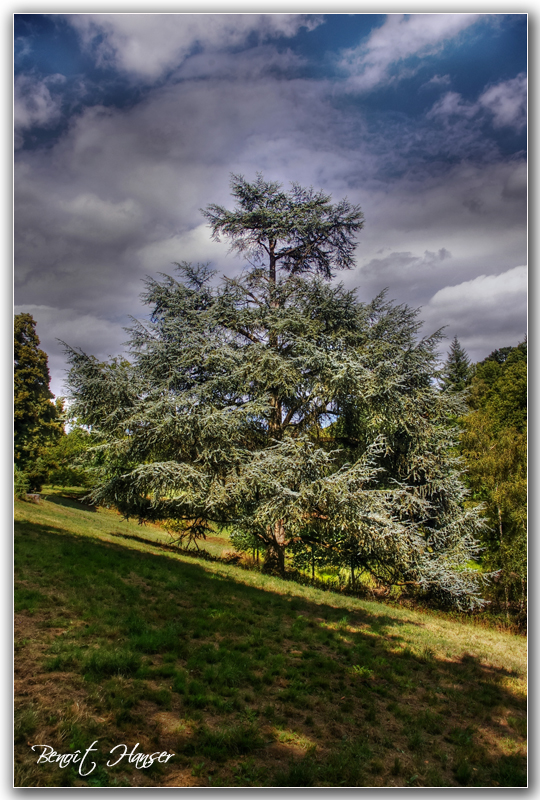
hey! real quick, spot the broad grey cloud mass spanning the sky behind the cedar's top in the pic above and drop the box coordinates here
[15,15,526,391]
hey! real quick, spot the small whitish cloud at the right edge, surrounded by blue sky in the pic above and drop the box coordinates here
[426,73,527,133]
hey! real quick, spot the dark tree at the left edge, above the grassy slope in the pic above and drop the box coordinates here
[13,314,63,491]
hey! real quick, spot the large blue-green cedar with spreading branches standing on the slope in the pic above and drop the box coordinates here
[63,176,486,606]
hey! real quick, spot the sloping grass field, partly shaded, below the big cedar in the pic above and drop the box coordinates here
[15,492,526,786]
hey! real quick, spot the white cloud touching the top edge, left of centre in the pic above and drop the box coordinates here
[66,14,322,82]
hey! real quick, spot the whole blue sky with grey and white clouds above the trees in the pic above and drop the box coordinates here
[14,13,527,395]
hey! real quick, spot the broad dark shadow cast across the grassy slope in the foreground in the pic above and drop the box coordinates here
[15,520,526,786]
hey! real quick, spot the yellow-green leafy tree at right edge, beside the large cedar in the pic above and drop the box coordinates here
[461,342,527,616]
